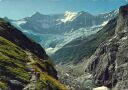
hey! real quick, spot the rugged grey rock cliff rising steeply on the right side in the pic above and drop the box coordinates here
[86,5,128,90]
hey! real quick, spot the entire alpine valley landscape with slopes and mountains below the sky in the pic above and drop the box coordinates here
[0,1,128,90]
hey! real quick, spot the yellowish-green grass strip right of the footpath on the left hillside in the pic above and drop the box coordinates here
[28,53,68,90]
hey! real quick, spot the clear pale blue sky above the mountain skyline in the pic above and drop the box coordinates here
[0,0,128,19]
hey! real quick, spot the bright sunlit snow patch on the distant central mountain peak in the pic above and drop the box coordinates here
[61,11,78,23]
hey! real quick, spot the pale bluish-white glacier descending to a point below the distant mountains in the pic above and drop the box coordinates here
[11,20,108,55]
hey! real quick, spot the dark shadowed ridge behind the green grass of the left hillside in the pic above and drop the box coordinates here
[0,17,48,59]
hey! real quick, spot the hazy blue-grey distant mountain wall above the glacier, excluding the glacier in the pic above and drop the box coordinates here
[17,11,118,34]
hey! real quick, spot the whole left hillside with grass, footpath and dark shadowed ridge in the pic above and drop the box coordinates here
[0,19,67,90]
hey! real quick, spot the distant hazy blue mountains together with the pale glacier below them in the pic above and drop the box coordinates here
[12,10,118,58]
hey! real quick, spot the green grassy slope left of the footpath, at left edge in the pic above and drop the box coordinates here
[0,37,30,87]
